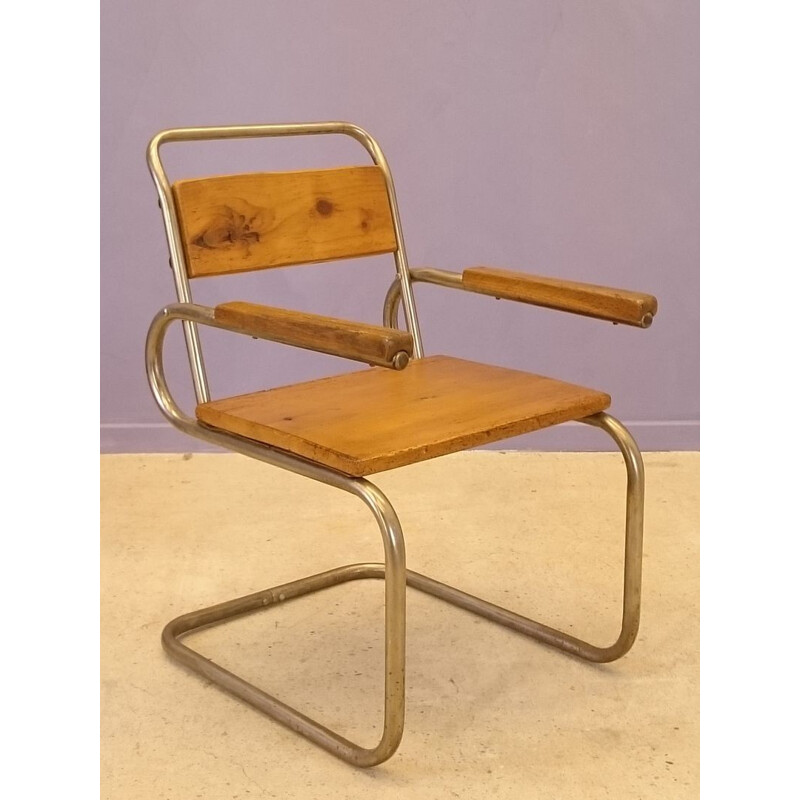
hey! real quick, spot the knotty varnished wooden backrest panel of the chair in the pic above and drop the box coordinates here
[172,166,397,278]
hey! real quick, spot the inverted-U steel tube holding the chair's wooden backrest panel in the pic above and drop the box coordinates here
[147,122,423,403]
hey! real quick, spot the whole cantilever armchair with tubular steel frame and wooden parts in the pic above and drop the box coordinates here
[146,122,657,767]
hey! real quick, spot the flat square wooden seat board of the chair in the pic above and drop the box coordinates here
[197,356,611,476]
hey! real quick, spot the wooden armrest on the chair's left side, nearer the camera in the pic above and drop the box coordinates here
[214,301,414,369]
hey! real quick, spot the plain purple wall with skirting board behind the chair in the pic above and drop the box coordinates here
[101,0,699,452]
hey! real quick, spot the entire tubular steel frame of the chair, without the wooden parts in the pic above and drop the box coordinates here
[145,122,644,767]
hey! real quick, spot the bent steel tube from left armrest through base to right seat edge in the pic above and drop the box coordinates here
[145,304,644,767]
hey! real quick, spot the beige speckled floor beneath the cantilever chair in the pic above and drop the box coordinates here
[102,452,699,800]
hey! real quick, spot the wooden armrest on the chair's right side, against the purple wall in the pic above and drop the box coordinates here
[462,267,658,328]
